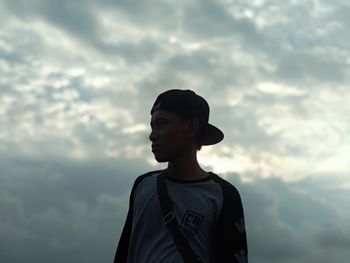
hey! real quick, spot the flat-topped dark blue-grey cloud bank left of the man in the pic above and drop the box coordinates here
[0,155,147,263]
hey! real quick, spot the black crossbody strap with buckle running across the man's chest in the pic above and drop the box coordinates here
[157,170,201,263]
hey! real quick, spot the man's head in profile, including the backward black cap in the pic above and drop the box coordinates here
[149,89,224,161]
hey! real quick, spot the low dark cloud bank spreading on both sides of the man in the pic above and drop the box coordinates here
[0,154,350,262]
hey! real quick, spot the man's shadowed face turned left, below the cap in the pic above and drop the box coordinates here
[149,110,191,162]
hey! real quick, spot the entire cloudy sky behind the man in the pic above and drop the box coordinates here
[0,0,350,263]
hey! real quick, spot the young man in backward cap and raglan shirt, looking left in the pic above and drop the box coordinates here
[114,89,248,263]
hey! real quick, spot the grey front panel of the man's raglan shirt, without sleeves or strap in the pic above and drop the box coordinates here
[128,172,223,263]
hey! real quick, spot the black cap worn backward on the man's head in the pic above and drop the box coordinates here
[151,89,224,145]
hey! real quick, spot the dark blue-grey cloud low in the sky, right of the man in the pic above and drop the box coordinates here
[228,175,350,262]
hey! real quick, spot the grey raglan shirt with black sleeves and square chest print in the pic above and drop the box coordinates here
[114,170,248,263]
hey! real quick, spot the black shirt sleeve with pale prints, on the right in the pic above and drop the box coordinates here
[214,181,248,263]
